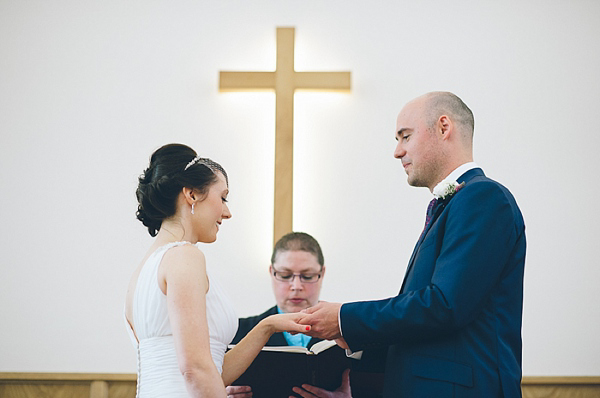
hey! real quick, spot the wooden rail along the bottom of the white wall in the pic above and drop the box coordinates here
[0,373,600,398]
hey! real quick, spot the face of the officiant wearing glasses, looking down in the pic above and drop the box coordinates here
[269,250,325,312]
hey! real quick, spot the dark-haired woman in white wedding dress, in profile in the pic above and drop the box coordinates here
[125,144,309,398]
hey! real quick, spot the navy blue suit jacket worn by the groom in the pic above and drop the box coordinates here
[340,168,525,398]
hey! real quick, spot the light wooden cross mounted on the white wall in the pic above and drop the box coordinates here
[219,28,350,243]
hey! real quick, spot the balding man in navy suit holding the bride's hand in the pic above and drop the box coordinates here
[301,92,525,398]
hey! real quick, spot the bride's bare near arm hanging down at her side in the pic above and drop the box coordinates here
[158,245,226,397]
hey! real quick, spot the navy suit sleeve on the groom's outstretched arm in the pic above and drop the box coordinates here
[340,180,520,351]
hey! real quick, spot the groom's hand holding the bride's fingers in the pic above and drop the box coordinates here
[298,301,342,340]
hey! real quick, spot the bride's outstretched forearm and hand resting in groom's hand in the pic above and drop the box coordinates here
[222,313,310,386]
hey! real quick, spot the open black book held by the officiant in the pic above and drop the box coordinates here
[229,340,352,398]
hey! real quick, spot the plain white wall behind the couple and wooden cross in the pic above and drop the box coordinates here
[0,0,600,375]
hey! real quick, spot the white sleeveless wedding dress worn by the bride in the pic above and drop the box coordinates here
[126,242,238,398]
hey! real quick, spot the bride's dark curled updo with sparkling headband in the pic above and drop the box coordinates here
[135,144,227,236]
